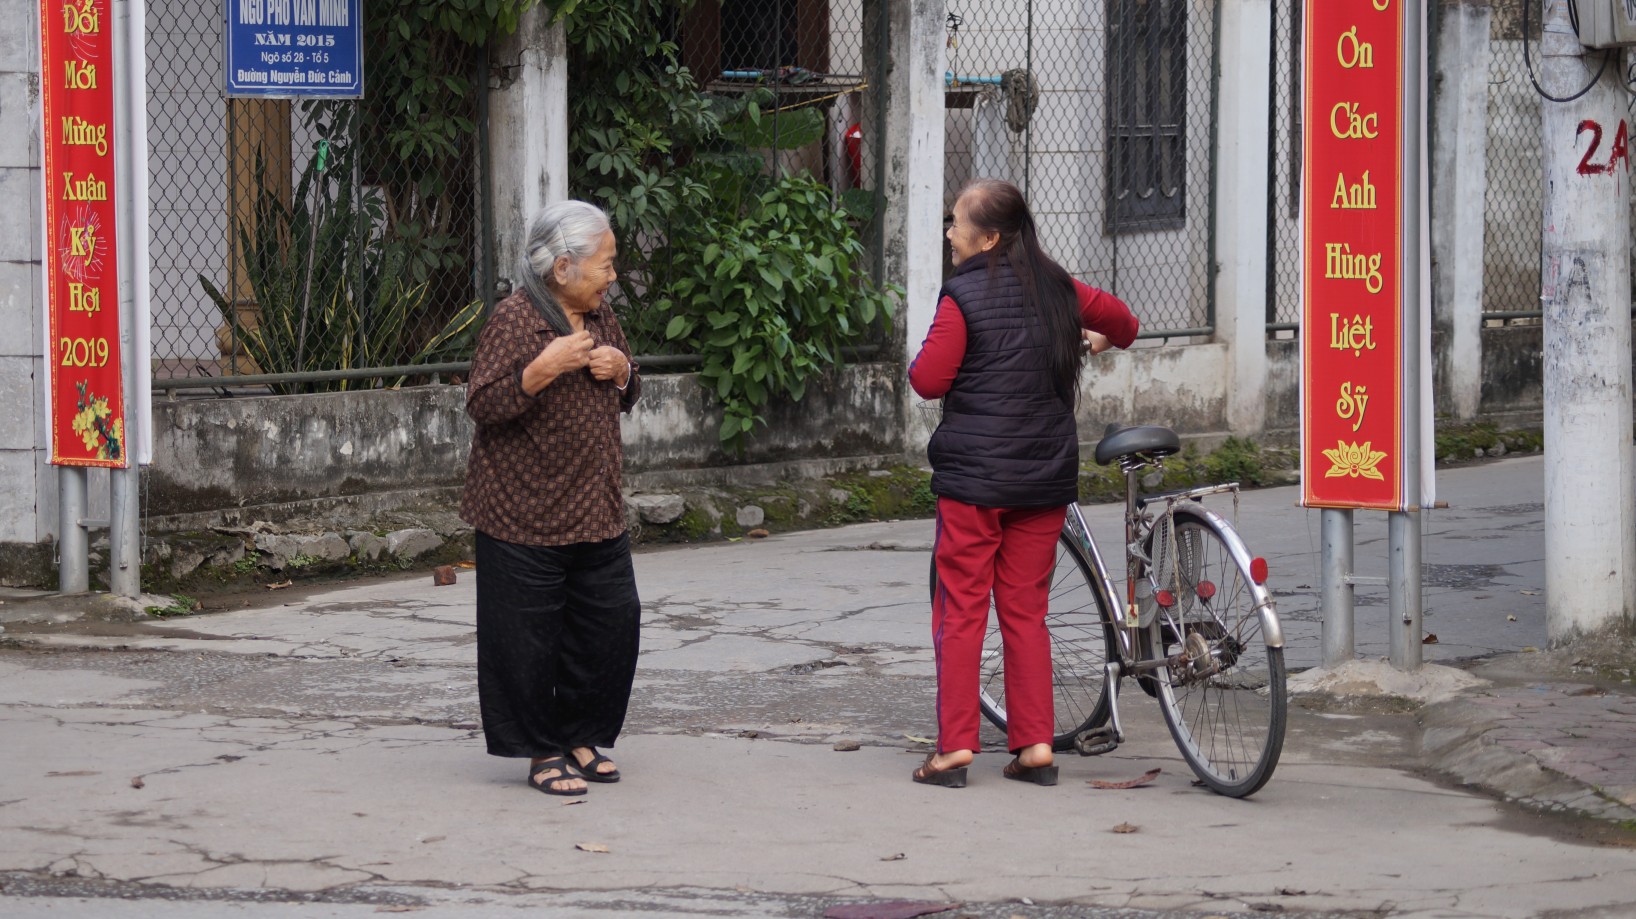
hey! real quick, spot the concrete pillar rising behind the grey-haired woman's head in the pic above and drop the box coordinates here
[488,5,568,286]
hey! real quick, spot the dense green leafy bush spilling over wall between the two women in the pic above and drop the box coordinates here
[566,0,900,450]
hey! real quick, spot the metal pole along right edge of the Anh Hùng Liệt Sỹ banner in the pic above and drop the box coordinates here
[1387,3,1425,670]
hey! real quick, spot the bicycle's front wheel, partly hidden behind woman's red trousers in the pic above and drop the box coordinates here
[931,531,1116,751]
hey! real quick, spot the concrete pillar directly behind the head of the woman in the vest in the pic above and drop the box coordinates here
[864,0,946,455]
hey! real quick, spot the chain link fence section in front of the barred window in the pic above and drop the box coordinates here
[944,0,1217,337]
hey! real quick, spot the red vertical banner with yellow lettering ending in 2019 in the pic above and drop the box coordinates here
[39,0,128,466]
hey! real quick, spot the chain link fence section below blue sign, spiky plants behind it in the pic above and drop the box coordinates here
[147,0,483,392]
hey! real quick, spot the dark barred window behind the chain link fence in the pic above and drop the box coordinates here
[1104,0,1188,232]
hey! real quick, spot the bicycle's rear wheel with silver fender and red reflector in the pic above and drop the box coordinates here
[1148,504,1288,798]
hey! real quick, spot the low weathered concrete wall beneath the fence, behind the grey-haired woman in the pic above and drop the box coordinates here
[147,365,903,517]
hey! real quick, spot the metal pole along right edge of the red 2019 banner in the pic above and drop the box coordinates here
[108,0,149,597]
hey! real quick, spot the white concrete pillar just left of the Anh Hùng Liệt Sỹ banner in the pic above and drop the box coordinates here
[1216,0,1273,433]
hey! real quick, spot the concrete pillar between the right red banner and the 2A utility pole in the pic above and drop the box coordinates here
[1430,0,1494,420]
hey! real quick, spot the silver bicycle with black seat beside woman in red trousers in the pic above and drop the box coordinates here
[931,425,1288,798]
